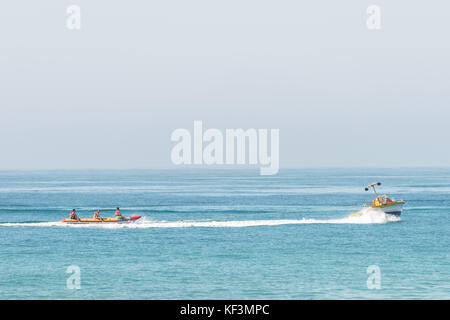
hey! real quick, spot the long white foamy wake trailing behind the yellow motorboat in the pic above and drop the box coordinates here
[0,208,401,229]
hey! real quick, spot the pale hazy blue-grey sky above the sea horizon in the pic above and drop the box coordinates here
[0,0,450,168]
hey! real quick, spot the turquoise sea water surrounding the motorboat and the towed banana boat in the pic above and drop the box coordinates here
[0,169,450,299]
